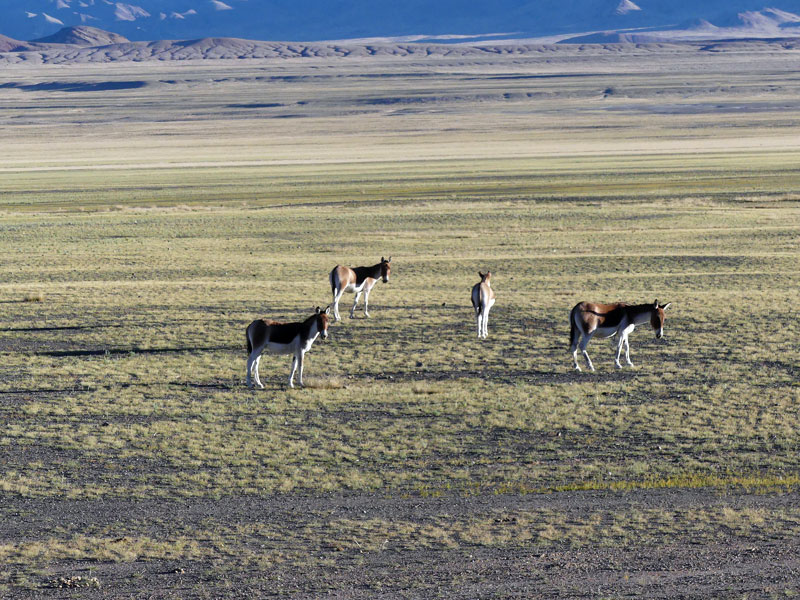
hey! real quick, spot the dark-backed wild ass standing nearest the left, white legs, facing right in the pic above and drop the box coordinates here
[247,306,331,388]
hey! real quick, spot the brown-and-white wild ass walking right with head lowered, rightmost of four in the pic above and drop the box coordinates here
[569,300,672,371]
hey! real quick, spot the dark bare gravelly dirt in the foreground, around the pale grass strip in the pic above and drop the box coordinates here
[6,490,800,599]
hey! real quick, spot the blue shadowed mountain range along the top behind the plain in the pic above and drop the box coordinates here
[0,0,800,44]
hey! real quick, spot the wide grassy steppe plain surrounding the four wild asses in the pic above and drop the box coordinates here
[0,43,800,598]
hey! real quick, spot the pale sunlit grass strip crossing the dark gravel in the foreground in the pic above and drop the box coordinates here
[6,500,800,567]
